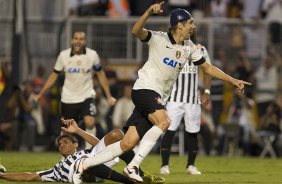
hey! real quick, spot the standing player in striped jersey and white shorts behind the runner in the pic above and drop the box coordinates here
[160,31,211,175]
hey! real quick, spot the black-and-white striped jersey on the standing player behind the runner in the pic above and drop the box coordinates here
[168,44,211,104]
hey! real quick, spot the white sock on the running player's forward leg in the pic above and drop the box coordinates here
[128,126,163,168]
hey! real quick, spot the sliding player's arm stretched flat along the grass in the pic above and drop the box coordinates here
[0,172,41,182]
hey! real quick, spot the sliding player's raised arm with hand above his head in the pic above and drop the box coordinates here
[61,118,100,146]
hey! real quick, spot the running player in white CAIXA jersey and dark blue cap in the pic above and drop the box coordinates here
[73,2,250,184]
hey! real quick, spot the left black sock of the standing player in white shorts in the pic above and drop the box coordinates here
[161,130,175,166]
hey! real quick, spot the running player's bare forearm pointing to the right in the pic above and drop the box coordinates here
[200,62,252,92]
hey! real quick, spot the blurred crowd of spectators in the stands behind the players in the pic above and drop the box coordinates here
[0,0,282,156]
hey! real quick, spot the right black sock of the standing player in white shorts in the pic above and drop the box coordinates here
[185,132,198,168]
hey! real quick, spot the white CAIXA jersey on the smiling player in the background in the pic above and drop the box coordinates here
[54,48,100,104]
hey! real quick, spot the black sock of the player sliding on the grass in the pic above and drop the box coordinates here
[82,164,134,184]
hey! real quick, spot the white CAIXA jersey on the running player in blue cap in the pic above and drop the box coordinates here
[133,31,202,102]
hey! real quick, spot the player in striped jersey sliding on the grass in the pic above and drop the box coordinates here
[0,119,164,184]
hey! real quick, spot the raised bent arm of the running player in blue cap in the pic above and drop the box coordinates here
[132,2,164,40]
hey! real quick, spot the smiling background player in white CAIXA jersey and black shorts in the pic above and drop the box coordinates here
[35,31,116,147]
